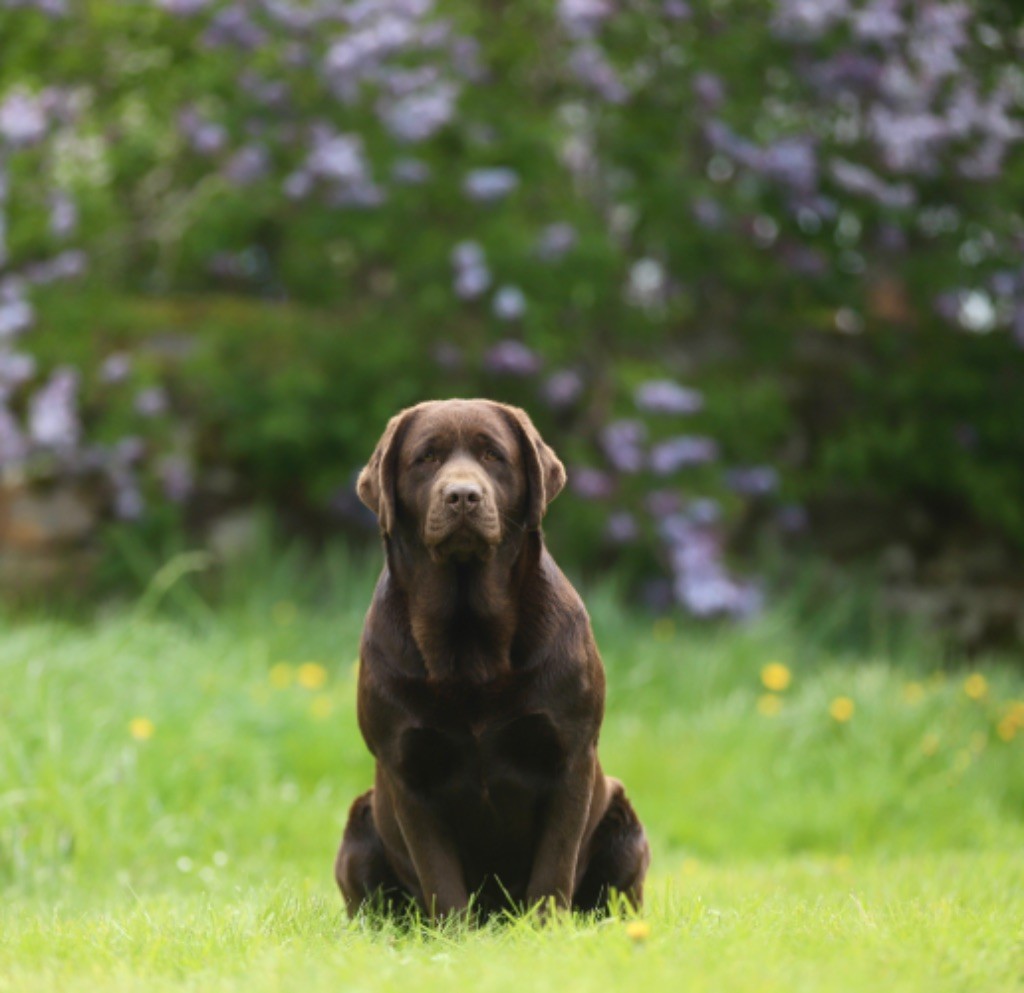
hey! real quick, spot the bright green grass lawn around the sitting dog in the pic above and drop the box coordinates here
[0,555,1024,993]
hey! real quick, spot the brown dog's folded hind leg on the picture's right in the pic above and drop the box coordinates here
[572,777,650,911]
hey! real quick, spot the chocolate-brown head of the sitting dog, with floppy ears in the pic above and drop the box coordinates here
[356,400,565,561]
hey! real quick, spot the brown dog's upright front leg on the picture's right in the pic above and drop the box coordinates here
[526,747,597,910]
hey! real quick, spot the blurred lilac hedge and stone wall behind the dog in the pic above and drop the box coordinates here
[0,0,1024,652]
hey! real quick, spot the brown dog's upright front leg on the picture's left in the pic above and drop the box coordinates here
[387,777,469,919]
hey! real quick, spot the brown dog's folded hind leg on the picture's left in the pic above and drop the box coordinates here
[334,789,413,916]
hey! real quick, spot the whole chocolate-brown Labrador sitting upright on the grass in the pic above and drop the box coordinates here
[335,400,650,916]
